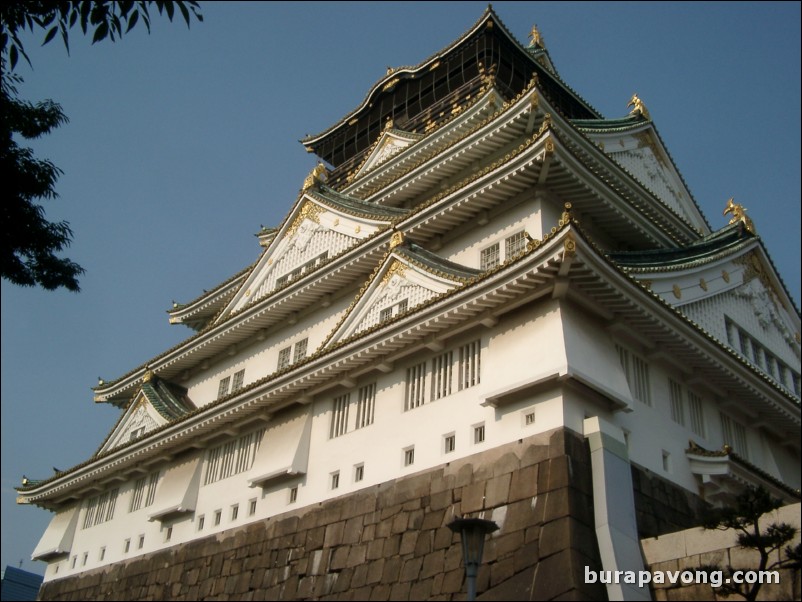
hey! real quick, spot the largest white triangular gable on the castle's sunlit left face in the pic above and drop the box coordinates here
[218,189,403,320]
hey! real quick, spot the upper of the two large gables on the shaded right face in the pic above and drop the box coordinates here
[575,119,709,232]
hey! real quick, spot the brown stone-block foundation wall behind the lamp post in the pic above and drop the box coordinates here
[40,429,606,600]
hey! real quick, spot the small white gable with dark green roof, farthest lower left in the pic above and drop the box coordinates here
[98,372,193,453]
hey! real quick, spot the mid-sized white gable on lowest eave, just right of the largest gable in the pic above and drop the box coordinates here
[327,234,478,344]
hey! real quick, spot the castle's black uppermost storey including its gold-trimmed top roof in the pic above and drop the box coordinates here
[301,8,601,168]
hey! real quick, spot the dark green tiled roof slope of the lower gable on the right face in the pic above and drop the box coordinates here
[608,222,755,270]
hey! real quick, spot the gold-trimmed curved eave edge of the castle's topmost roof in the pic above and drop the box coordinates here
[301,7,601,152]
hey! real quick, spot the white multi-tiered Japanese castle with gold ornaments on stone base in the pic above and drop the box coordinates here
[17,8,802,600]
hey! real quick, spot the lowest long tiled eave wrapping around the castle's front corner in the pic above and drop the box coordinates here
[18,220,802,508]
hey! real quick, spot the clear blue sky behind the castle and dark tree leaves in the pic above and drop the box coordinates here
[0,2,800,572]
